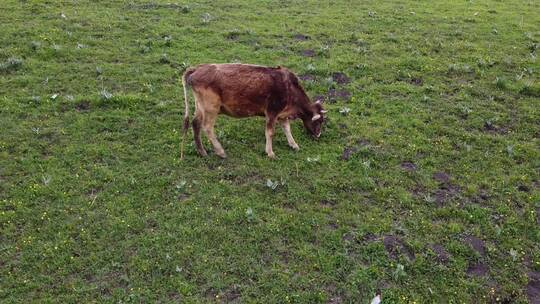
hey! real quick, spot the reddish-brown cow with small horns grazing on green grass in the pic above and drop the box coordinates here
[181,64,325,158]
